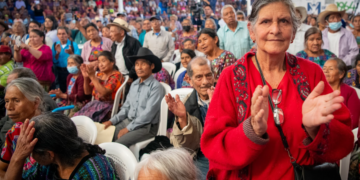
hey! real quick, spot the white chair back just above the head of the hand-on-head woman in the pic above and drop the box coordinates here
[71,116,97,144]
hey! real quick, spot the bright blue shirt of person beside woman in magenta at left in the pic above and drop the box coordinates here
[51,40,81,68]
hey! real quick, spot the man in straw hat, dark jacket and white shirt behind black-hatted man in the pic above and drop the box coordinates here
[107,18,141,80]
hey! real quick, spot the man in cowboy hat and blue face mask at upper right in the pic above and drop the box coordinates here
[318,4,359,66]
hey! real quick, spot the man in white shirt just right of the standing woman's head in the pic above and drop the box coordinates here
[287,6,311,55]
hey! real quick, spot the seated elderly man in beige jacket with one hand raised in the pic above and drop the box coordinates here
[165,57,215,175]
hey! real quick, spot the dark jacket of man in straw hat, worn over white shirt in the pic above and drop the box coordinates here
[111,33,141,80]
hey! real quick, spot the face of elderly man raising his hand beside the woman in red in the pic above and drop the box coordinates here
[190,63,215,97]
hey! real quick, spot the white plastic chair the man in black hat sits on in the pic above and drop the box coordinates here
[130,82,171,161]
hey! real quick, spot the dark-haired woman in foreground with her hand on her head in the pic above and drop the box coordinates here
[5,113,119,180]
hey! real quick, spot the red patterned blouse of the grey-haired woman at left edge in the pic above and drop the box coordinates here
[1,122,36,178]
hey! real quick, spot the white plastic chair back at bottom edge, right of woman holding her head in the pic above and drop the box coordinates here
[99,142,137,180]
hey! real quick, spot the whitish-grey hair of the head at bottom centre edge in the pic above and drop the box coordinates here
[135,148,200,180]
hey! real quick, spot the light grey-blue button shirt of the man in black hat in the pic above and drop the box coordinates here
[110,75,165,131]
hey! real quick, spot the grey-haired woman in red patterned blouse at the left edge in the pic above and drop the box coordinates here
[0,78,45,179]
